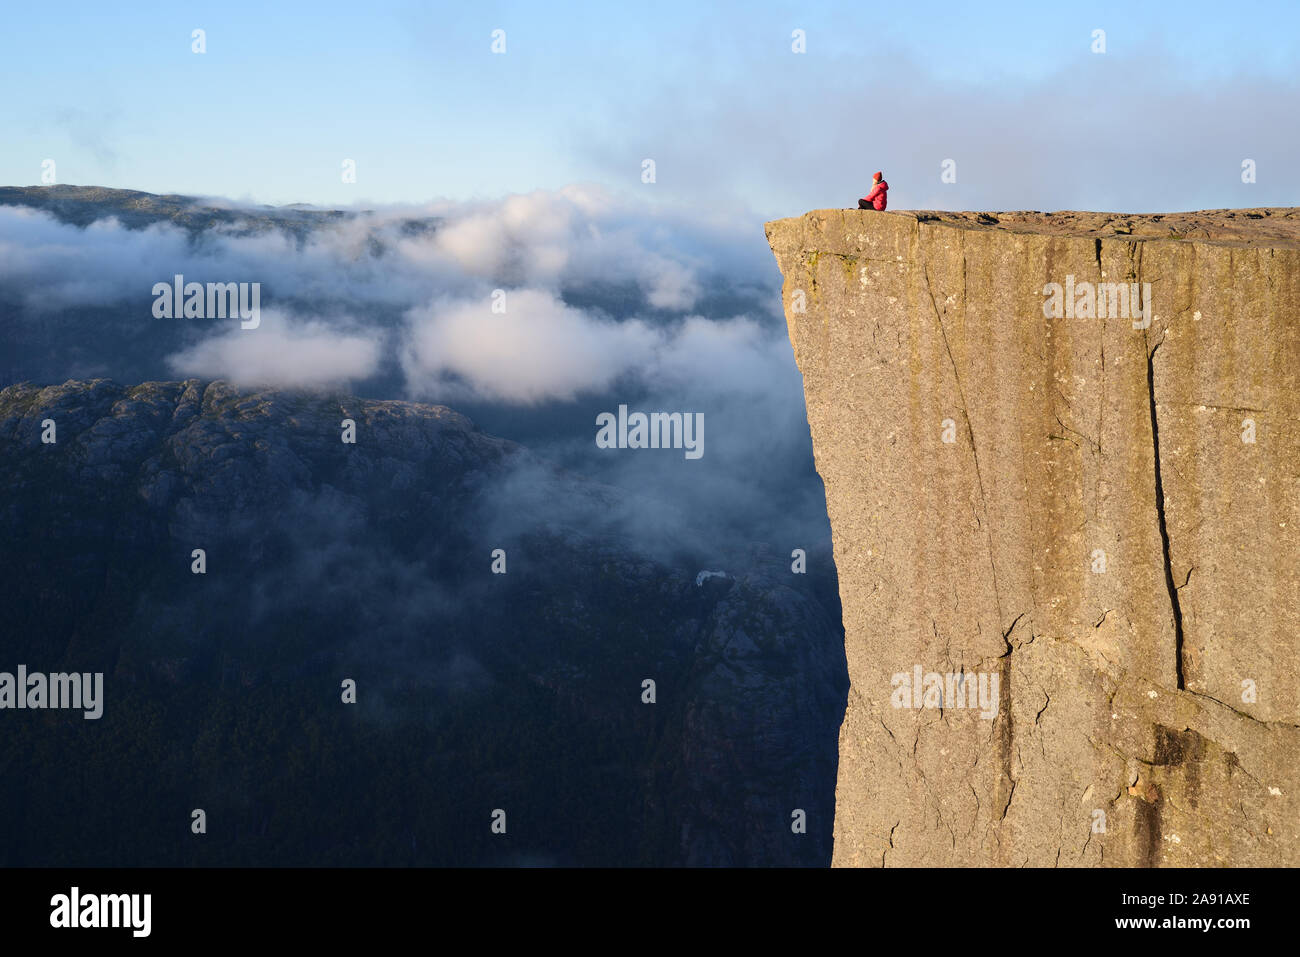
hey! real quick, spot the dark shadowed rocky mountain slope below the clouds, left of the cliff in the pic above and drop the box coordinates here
[0,380,845,865]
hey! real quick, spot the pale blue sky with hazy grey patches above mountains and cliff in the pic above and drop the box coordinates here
[0,0,1300,216]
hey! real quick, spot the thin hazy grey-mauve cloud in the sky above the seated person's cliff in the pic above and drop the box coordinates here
[576,43,1300,218]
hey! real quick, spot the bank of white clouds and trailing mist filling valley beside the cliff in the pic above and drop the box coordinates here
[0,186,827,567]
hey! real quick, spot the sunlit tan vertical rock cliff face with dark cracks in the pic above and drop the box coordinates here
[767,209,1300,866]
